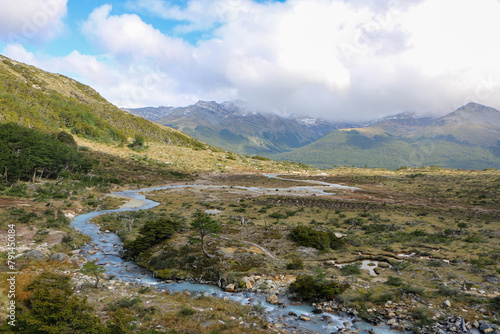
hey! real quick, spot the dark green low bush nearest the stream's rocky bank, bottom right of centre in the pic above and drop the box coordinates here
[289,275,348,301]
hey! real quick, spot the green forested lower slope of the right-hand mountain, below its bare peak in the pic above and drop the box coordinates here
[272,130,500,169]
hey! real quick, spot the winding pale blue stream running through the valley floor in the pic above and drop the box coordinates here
[71,174,397,334]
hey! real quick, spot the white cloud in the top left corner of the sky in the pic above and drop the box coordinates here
[0,0,67,43]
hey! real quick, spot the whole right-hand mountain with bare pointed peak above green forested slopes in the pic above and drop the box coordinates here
[271,103,500,169]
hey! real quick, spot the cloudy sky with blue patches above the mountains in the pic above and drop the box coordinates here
[0,0,500,120]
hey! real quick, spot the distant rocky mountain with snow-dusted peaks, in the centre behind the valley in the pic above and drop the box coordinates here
[124,101,353,155]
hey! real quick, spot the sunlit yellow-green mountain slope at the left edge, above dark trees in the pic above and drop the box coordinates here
[0,55,204,147]
